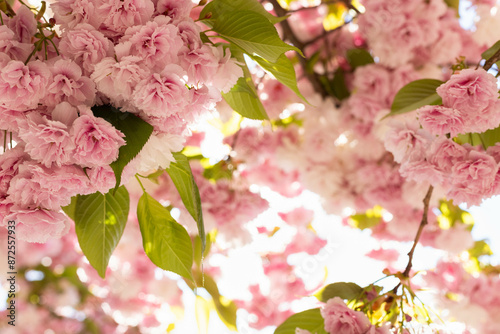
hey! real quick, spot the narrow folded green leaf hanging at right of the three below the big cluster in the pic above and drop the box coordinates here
[166,152,206,251]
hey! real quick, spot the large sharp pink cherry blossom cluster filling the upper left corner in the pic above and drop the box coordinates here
[0,0,243,242]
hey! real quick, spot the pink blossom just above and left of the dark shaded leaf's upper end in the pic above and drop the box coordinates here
[44,59,96,106]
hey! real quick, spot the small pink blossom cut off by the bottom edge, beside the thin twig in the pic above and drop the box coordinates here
[321,297,371,334]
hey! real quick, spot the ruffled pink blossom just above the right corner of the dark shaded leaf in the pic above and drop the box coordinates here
[132,64,189,117]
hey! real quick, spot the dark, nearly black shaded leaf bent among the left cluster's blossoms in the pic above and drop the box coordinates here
[92,104,153,191]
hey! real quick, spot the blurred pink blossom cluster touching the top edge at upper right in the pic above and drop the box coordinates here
[358,0,484,67]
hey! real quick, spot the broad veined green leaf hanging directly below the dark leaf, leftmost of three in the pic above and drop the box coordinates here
[74,186,130,278]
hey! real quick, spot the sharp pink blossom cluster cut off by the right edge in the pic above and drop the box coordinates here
[385,69,500,205]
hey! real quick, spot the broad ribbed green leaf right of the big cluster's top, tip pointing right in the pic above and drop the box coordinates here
[213,10,302,63]
